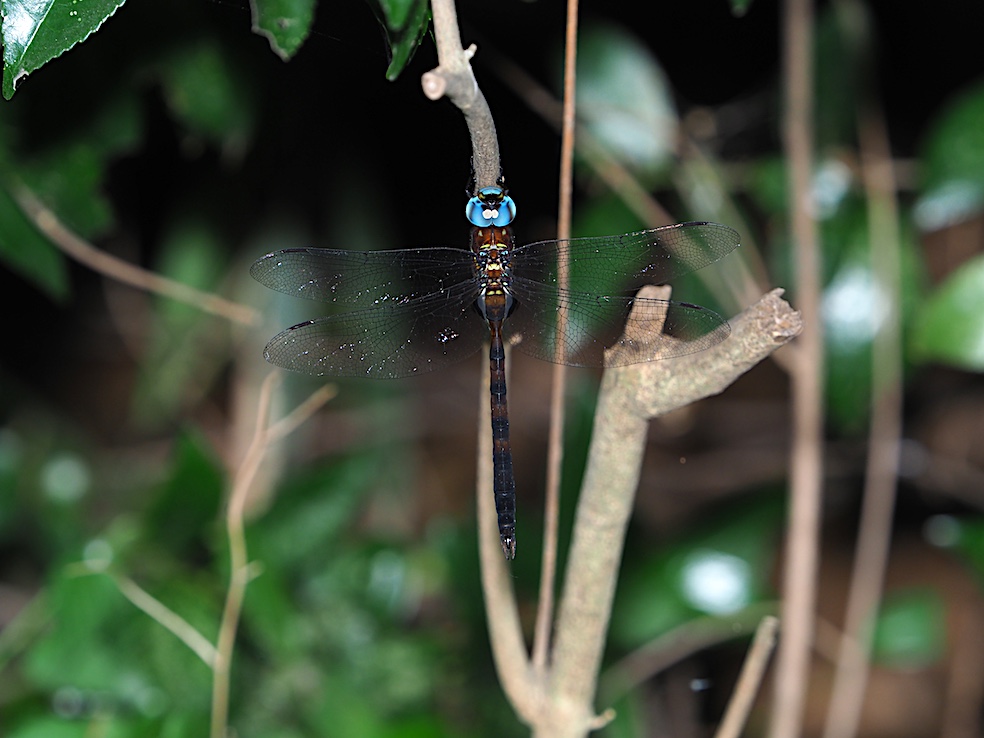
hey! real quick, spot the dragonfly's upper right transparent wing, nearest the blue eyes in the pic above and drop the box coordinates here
[512,218,740,295]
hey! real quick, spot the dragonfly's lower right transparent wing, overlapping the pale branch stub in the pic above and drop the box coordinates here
[504,278,731,366]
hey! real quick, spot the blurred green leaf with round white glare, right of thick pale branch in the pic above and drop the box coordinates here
[611,499,782,648]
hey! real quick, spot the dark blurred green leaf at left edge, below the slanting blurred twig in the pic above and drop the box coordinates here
[0,187,69,300]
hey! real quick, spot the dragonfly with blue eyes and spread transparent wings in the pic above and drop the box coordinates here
[250,186,739,559]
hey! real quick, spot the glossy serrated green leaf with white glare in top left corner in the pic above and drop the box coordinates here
[0,0,125,100]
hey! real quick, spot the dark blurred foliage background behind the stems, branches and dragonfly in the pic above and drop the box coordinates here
[0,0,984,738]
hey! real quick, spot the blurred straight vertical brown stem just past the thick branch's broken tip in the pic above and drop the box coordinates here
[770,0,824,738]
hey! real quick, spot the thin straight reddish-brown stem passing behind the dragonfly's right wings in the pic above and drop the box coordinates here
[533,0,578,670]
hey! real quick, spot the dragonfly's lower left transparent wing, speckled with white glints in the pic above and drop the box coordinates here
[264,284,488,379]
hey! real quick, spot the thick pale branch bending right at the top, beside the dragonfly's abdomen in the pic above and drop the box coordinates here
[549,288,801,732]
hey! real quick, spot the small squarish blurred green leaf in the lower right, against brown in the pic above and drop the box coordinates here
[872,589,946,669]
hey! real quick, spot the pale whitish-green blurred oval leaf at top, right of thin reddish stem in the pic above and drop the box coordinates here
[577,25,677,180]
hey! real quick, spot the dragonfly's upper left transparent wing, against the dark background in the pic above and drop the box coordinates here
[249,248,475,311]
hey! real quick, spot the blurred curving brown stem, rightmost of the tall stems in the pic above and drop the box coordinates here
[824,1,902,738]
